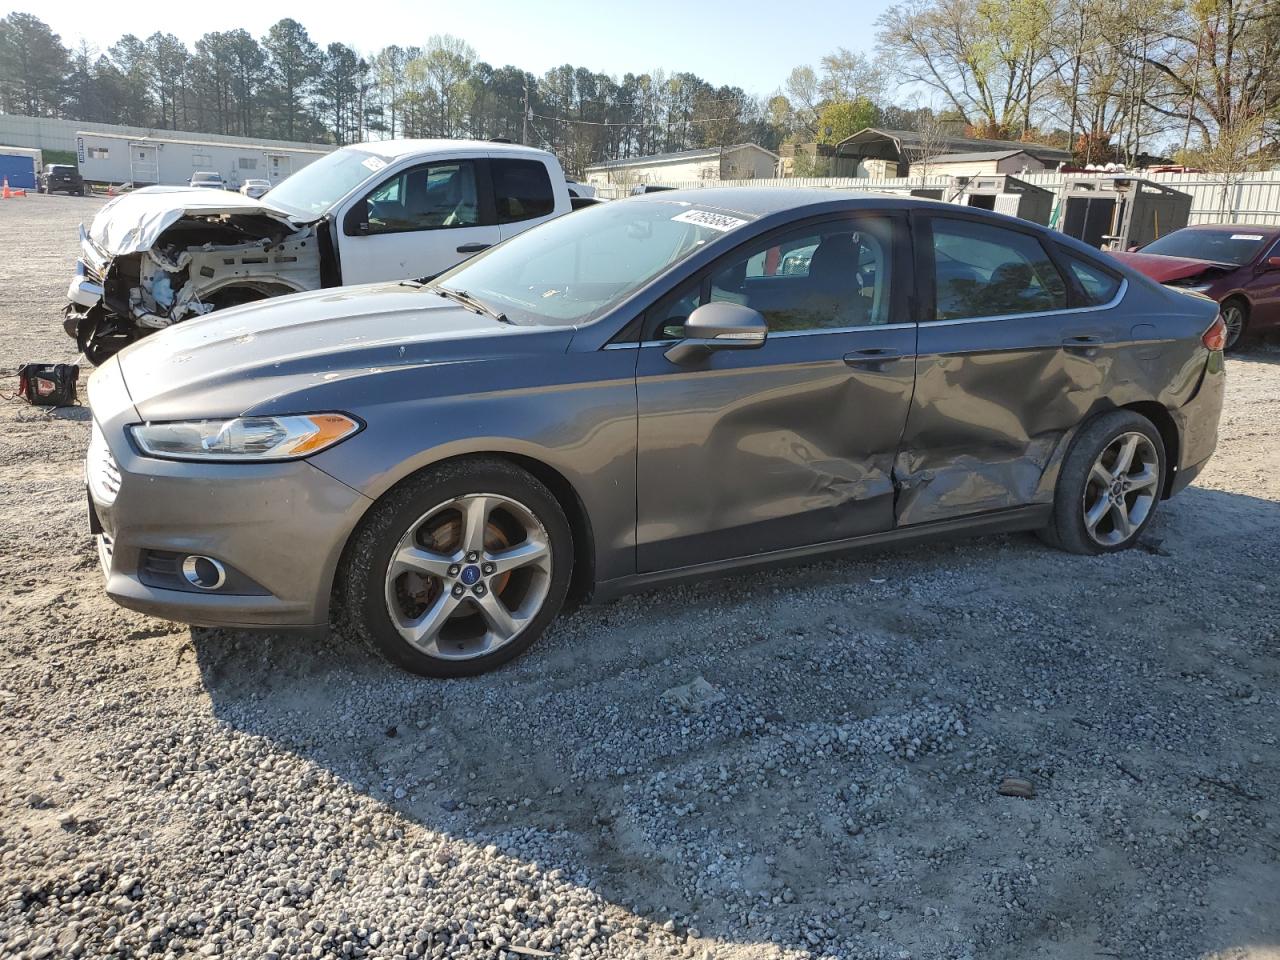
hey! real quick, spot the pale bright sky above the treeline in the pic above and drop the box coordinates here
[0,0,892,95]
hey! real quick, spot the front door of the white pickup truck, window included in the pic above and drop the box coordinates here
[339,157,502,284]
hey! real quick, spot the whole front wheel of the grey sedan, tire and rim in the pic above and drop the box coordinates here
[340,460,573,677]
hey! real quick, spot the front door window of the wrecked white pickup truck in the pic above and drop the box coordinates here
[365,160,480,234]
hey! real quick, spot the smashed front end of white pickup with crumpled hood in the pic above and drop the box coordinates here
[64,188,324,364]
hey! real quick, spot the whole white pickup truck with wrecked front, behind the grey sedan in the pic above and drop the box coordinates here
[64,140,576,364]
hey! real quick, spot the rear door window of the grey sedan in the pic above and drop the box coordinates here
[933,218,1066,320]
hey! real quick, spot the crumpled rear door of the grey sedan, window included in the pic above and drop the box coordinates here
[895,212,1124,526]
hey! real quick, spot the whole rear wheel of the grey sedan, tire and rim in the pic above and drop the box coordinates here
[1043,410,1166,554]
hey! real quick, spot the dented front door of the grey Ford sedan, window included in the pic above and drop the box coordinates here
[636,212,915,572]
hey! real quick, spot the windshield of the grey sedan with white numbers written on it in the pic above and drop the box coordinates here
[432,199,750,324]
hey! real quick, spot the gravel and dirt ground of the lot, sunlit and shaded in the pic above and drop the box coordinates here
[0,197,1280,960]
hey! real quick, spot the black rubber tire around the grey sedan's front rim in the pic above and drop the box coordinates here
[335,458,573,677]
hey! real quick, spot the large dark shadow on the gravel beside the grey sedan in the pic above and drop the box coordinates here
[192,486,1280,959]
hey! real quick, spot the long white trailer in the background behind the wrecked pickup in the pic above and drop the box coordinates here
[76,131,333,189]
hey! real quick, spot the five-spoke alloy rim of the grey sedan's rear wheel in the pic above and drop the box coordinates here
[1084,431,1160,547]
